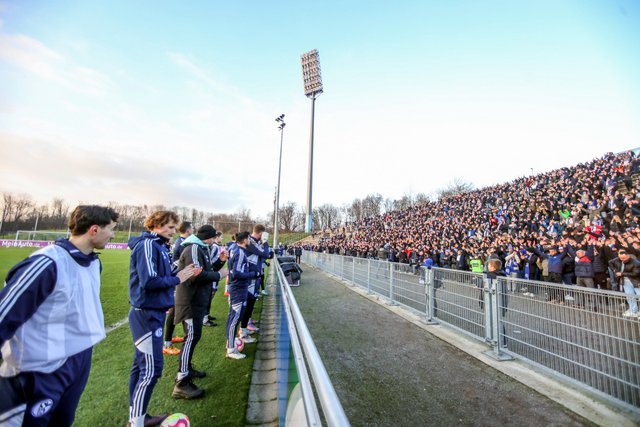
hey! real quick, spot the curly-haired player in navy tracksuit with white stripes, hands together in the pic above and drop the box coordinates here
[129,211,199,427]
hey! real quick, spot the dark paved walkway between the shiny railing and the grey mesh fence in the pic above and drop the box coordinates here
[294,266,631,427]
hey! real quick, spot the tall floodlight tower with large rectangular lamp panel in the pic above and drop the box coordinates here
[300,49,322,233]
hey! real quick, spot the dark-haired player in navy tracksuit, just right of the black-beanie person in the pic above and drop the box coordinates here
[226,231,258,359]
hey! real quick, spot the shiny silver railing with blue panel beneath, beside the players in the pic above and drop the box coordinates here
[272,259,350,427]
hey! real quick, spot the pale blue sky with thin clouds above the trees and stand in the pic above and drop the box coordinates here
[0,0,640,215]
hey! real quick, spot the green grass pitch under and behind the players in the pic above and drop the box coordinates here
[0,248,262,427]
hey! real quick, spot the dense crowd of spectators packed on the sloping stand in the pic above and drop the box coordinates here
[308,151,640,310]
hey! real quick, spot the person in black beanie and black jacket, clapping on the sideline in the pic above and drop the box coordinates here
[172,224,228,399]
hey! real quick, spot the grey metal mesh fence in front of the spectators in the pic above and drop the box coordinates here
[302,251,640,413]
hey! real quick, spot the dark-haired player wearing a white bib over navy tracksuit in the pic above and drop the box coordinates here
[0,205,118,427]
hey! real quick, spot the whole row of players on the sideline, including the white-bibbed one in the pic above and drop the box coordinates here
[0,205,272,427]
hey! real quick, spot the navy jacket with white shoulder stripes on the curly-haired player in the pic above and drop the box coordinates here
[129,231,180,310]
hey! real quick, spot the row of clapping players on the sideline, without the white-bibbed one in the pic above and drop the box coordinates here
[129,211,273,426]
